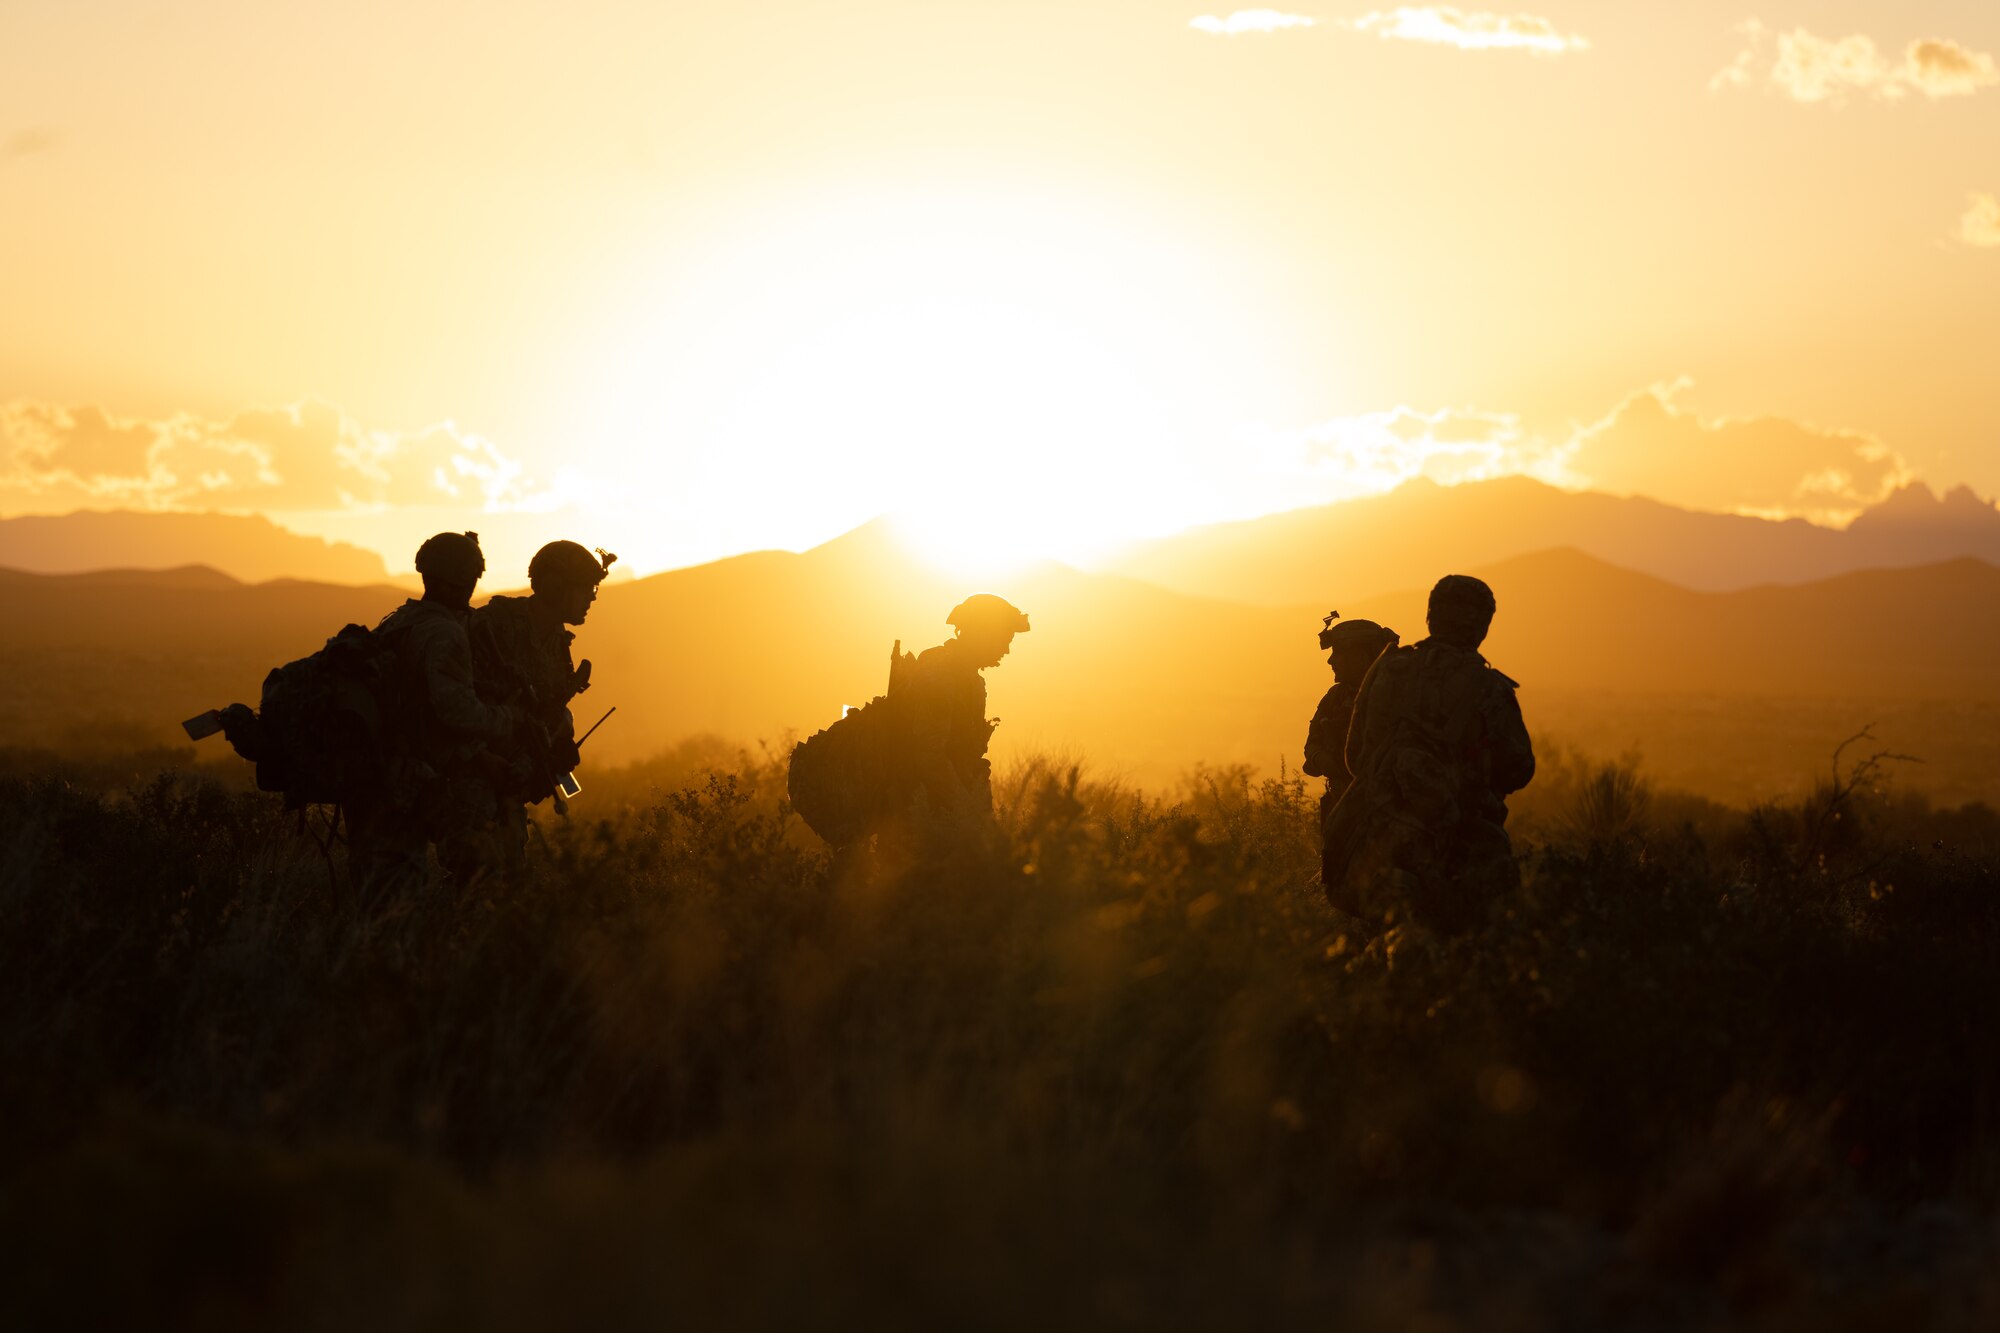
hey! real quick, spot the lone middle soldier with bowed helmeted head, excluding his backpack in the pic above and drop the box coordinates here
[908,592,1028,817]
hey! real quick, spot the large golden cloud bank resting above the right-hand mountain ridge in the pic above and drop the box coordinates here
[1564,384,1912,522]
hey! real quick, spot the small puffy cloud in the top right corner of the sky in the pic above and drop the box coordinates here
[1708,22,2000,104]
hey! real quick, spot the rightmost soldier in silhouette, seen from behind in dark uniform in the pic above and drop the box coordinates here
[1326,574,1534,935]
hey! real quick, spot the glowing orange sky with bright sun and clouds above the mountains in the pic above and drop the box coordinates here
[0,0,2000,568]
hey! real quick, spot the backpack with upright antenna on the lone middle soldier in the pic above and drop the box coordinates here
[786,638,916,847]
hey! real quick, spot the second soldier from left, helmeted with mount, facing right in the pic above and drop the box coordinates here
[460,542,618,881]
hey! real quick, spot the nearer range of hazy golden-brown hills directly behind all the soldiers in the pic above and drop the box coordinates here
[0,524,2000,801]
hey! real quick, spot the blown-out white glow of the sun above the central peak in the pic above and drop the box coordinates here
[578,182,1296,568]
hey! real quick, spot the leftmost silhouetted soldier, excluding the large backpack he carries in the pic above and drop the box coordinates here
[356,532,526,897]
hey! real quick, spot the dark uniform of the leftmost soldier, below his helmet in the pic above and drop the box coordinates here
[344,600,520,893]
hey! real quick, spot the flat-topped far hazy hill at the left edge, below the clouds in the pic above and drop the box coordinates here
[0,510,390,584]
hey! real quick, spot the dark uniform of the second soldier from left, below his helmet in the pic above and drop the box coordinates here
[464,596,590,879]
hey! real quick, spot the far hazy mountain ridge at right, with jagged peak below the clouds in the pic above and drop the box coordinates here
[1110,476,2000,610]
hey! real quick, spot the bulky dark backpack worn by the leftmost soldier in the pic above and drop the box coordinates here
[244,624,404,811]
